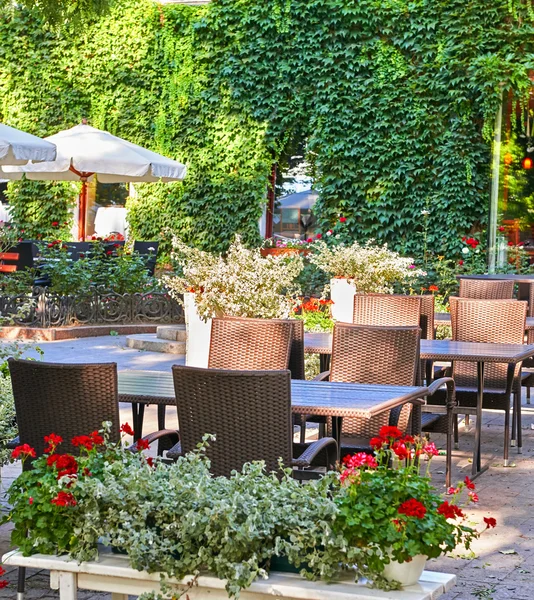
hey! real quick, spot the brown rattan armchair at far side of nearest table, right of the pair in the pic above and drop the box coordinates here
[319,323,454,480]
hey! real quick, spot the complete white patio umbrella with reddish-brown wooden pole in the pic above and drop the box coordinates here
[0,123,187,240]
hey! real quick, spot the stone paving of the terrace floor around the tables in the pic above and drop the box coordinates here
[0,336,534,600]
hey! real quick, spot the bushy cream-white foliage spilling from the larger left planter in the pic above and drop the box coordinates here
[164,236,304,319]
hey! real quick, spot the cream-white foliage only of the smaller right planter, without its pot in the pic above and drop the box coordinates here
[309,240,425,294]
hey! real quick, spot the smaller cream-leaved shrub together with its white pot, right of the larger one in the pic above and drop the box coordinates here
[308,240,424,323]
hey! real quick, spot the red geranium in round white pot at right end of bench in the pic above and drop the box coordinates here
[334,426,496,586]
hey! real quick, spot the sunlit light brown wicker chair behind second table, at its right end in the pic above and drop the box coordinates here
[435,298,527,462]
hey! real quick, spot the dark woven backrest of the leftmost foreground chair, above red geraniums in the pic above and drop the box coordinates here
[8,358,120,455]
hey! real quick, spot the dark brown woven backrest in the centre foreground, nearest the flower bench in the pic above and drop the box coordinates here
[172,365,293,476]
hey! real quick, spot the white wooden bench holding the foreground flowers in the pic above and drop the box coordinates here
[2,548,456,600]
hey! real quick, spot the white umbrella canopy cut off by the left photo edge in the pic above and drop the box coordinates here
[0,123,56,165]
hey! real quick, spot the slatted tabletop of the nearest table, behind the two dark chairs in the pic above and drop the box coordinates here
[118,370,430,419]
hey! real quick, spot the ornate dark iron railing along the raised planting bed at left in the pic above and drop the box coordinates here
[0,287,184,327]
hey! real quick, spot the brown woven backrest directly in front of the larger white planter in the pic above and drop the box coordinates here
[208,318,293,371]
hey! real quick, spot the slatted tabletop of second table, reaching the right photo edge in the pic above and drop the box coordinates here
[304,333,534,363]
